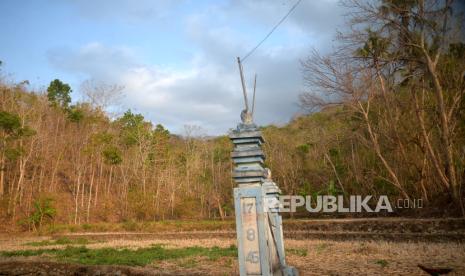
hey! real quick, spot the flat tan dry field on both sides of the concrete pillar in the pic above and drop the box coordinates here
[0,236,465,275]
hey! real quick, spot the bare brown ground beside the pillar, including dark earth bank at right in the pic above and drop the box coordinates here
[0,219,465,275]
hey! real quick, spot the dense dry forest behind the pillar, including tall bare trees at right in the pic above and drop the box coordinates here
[0,0,465,229]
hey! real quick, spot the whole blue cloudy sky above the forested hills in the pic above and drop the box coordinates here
[0,0,344,135]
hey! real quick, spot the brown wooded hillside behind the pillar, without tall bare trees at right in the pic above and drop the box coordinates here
[0,75,463,229]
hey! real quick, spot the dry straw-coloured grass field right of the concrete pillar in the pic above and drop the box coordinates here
[286,240,465,275]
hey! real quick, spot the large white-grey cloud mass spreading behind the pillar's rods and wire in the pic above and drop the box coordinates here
[49,0,344,134]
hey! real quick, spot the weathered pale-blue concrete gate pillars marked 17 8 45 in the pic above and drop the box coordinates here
[229,120,298,275]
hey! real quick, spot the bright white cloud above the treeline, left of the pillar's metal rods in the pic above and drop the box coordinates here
[49,43,240,134]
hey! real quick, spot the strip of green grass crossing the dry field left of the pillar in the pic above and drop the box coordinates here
[1,245,237,266]
